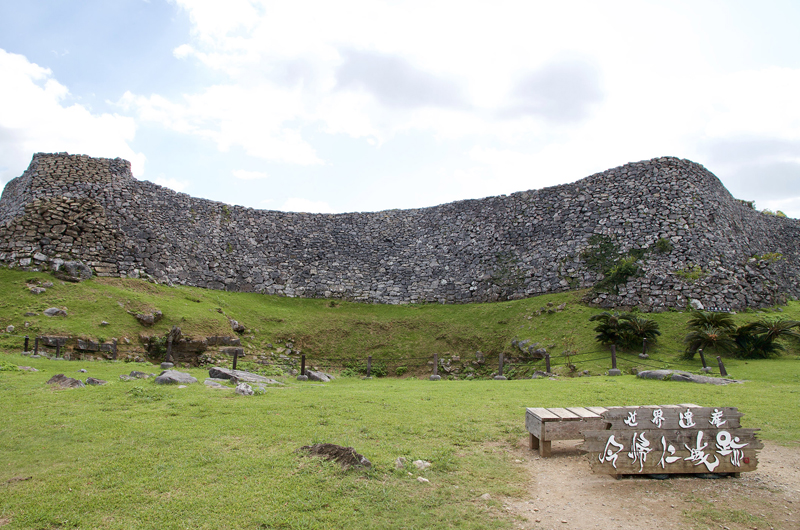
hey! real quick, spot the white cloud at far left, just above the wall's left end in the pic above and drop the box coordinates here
[0,49,145,182]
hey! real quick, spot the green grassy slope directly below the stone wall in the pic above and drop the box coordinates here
[0,270,800,374]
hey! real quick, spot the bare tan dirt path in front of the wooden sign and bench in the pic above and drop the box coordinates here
[503,439,800,530]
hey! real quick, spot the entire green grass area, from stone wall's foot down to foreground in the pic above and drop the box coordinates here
[0,270,800,529]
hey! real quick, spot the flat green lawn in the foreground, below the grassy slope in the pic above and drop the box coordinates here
[0,355,800,528]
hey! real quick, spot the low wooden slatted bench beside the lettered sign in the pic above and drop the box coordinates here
[525,407,607,456]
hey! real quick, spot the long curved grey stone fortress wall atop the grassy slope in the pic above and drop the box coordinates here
[0,153,800,311]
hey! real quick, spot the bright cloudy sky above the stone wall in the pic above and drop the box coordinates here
[0,0,800,218]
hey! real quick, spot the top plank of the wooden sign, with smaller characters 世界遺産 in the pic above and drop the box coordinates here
[603,405,742,429]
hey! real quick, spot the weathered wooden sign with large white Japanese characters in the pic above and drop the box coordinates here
[582,405,763,475]
